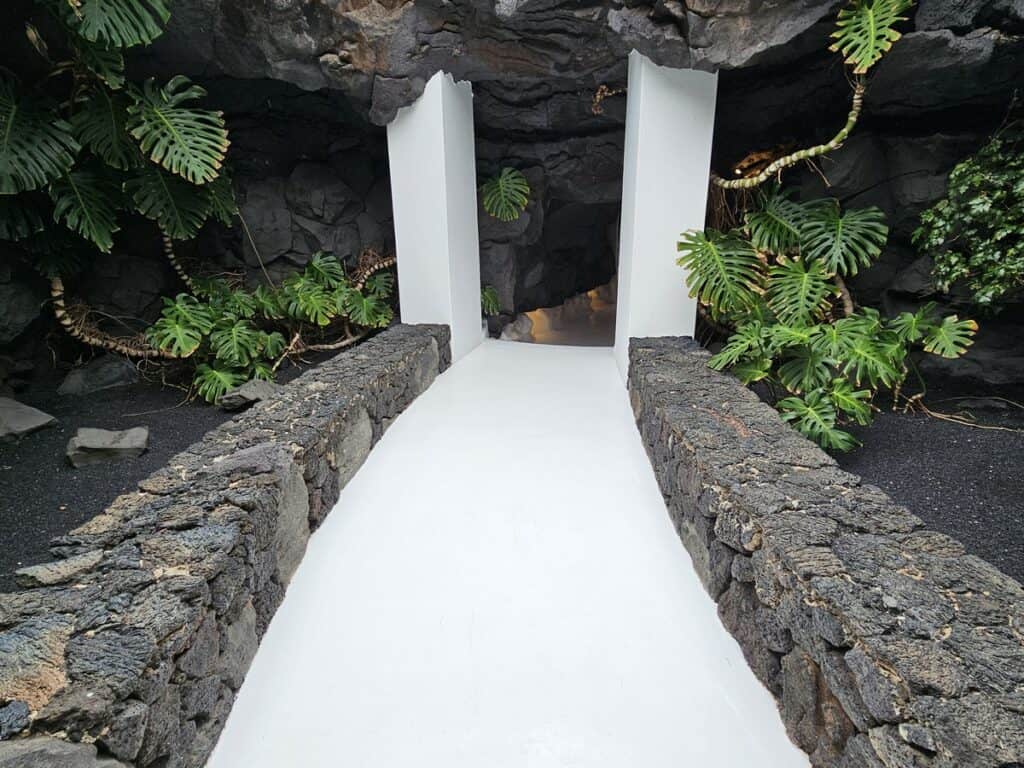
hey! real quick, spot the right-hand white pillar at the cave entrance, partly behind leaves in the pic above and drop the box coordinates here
[614,51,718,380]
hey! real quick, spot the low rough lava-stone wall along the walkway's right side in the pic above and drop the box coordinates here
[630,339,1024,768]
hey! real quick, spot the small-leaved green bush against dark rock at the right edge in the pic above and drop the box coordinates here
[913,122,1024,306]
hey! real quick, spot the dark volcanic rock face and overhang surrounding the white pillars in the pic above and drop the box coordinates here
[0,0,1024,391]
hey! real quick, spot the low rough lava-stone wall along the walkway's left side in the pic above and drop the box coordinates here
[0,326,450,768]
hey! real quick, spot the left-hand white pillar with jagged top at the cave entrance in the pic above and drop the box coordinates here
[387,72,482,360]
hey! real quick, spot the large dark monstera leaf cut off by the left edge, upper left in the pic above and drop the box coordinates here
[0,77,79,195]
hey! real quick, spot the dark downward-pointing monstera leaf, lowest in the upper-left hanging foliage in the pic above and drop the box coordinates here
[49,167,120,253]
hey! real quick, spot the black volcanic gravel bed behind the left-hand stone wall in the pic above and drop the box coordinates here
[0,384,231,591]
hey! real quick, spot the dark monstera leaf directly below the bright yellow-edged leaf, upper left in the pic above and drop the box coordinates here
[125,165,210,240]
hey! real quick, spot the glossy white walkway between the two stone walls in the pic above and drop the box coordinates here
[209,342,808,768]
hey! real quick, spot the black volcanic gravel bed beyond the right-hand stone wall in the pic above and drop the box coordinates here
[837,392,1024,582]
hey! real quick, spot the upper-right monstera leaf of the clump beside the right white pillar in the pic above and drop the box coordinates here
[800,200,889,275]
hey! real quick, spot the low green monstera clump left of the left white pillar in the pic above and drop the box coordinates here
[146,253,394,402]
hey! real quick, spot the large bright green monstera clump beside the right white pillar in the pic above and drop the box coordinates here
[679,189,977,451]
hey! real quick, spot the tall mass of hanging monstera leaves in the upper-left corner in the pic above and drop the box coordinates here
[0,0,237,272]
